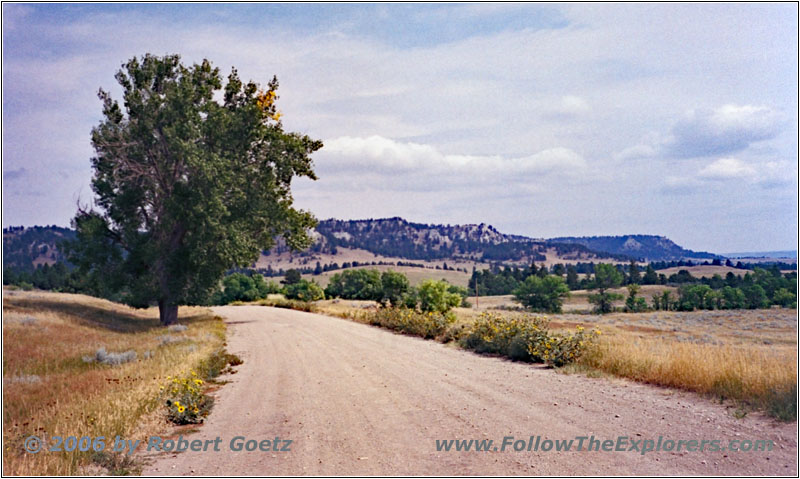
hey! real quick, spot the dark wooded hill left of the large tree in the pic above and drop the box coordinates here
[3,226,75,270]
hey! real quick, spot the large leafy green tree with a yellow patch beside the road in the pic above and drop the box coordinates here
[67,54,322,323]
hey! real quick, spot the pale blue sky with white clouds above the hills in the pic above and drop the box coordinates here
[2,3,798,253]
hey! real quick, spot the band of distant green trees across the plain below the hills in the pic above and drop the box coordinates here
[3,256,797,312]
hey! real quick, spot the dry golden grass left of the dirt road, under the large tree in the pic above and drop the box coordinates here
[3,290,225,475]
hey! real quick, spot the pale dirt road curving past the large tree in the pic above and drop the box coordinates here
[144,306,797,475]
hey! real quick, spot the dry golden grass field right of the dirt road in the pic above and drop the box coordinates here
[552,309,797,418]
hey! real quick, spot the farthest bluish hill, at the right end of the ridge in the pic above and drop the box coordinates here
[547,235,724,261]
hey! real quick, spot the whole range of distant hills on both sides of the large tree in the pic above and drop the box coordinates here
[3,217,721,273]
